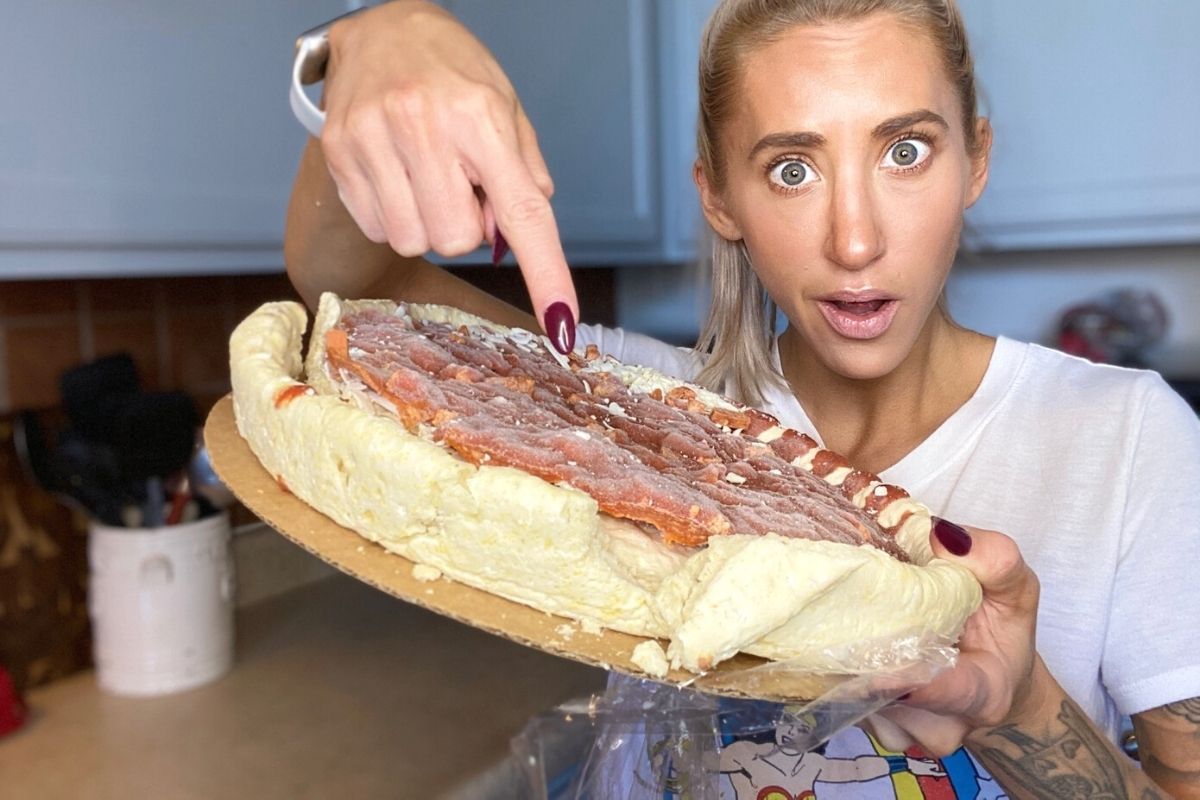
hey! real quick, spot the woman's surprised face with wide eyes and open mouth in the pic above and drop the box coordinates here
[697,14,988,379]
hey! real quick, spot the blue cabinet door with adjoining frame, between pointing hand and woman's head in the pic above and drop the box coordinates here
[442,0,714,264]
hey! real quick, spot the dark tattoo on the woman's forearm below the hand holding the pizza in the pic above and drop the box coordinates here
[977,700,1165,800]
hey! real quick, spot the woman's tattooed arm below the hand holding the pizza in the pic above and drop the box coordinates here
[967,658,1180,800]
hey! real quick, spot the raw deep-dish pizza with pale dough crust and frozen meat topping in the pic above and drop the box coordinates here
[230,295,980,675]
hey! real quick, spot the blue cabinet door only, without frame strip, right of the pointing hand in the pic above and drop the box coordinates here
[442,0,662,263]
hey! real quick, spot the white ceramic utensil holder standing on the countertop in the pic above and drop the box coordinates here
[88,513,234,696]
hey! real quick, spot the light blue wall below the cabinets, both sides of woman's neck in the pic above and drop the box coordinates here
[617,245,1200,378]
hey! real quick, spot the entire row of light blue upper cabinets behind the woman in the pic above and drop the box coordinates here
[9,0,1200,279]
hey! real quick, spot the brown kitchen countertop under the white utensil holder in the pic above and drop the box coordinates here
[0,573,605,800]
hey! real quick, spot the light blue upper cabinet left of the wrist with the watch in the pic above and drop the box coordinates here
[0,0,347,281]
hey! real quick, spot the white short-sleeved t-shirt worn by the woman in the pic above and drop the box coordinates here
[578,325,1200,796]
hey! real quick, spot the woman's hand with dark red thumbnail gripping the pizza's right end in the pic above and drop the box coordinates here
[871,519,1046,756]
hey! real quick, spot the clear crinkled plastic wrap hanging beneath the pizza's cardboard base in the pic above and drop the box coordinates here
[512,637,958,800]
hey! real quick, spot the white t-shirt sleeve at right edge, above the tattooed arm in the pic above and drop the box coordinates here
[1099,375,1200,714]
